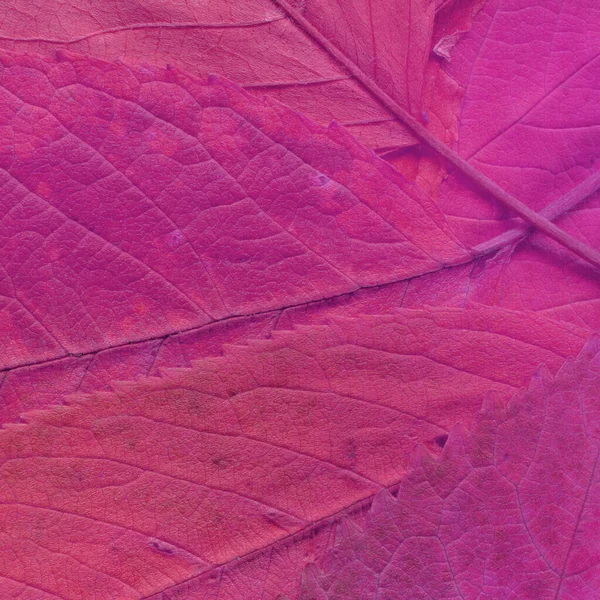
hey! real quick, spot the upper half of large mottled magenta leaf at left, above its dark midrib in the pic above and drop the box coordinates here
[0,55,468,368]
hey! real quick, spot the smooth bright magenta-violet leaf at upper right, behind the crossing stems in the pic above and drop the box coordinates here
[398,1,600,330]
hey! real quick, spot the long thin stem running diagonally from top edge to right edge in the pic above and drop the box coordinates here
[273,0,600,268]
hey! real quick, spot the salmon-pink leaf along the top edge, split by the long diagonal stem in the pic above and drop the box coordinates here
[0,0,474,149]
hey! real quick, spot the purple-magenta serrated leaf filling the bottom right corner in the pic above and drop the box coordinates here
[300,339,600,600]
